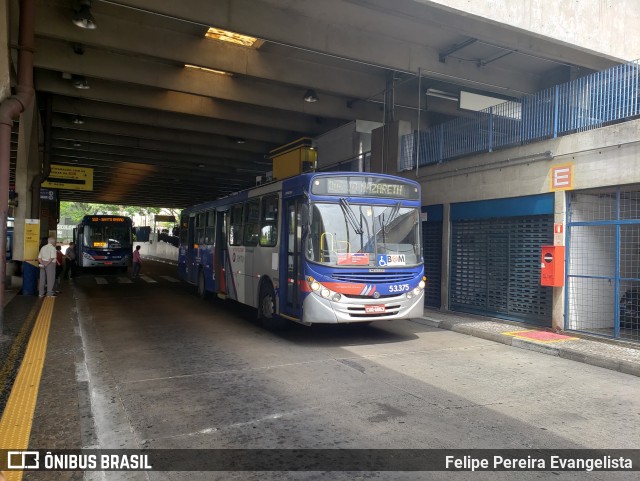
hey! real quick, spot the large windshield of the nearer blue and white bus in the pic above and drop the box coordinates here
[305,199,422,267]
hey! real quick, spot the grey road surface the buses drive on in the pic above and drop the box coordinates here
[67,261,640,480]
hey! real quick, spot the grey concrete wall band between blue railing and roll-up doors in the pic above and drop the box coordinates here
[418,120,640,205]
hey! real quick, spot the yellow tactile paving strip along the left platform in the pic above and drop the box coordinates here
[0,297,55,481]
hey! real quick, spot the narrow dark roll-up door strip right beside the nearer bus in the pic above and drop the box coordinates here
[422,205,442,307]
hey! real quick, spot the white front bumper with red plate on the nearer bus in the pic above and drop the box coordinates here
[302,291,424,324]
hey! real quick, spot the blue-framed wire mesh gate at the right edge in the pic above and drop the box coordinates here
[565,186,640,341]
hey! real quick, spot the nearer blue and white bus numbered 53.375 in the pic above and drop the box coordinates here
[178,172,425,327]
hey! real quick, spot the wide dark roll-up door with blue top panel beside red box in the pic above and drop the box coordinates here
[449,196,553,326]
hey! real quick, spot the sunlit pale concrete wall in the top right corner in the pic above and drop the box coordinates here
[414,0,640,60]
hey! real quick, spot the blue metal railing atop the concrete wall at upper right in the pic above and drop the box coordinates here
[400,60,640,170]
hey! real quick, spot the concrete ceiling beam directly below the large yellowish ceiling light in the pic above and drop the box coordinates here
[36,3,385,98]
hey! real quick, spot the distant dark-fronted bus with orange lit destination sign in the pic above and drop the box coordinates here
[73,215,133,271]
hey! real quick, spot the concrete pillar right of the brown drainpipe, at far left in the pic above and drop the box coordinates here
[13,102,43,260]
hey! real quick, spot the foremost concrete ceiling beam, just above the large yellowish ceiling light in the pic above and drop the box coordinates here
[109,0,540,95]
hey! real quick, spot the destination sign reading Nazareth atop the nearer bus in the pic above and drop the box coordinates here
[311,176,418,200]
